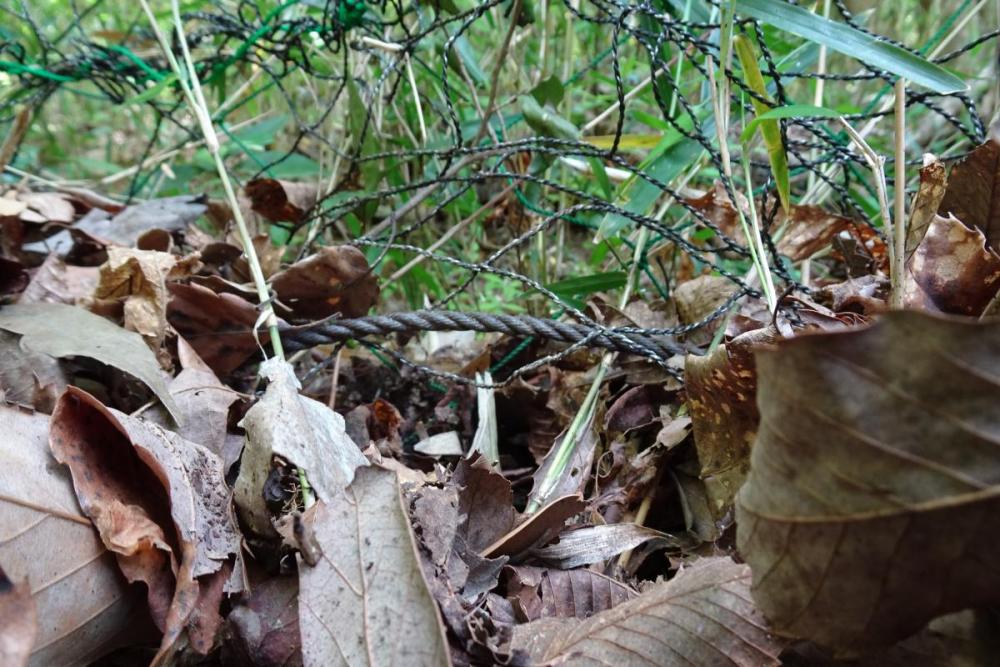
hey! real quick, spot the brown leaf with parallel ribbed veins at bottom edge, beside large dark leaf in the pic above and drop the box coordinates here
[511,558,782,667]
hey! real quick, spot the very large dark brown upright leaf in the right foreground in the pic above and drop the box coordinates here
[737,311,1000,649]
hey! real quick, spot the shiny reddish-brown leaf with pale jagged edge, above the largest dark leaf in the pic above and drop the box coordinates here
[904,216,1000,317]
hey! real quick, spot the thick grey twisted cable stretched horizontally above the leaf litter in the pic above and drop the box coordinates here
[281,310,693,363]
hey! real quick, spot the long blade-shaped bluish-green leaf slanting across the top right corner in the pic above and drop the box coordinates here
[735,0,967,94]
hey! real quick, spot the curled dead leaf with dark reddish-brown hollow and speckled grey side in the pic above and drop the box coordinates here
[49,387,244,659]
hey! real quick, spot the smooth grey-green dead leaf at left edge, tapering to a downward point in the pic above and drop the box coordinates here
[0,303,183,423]
